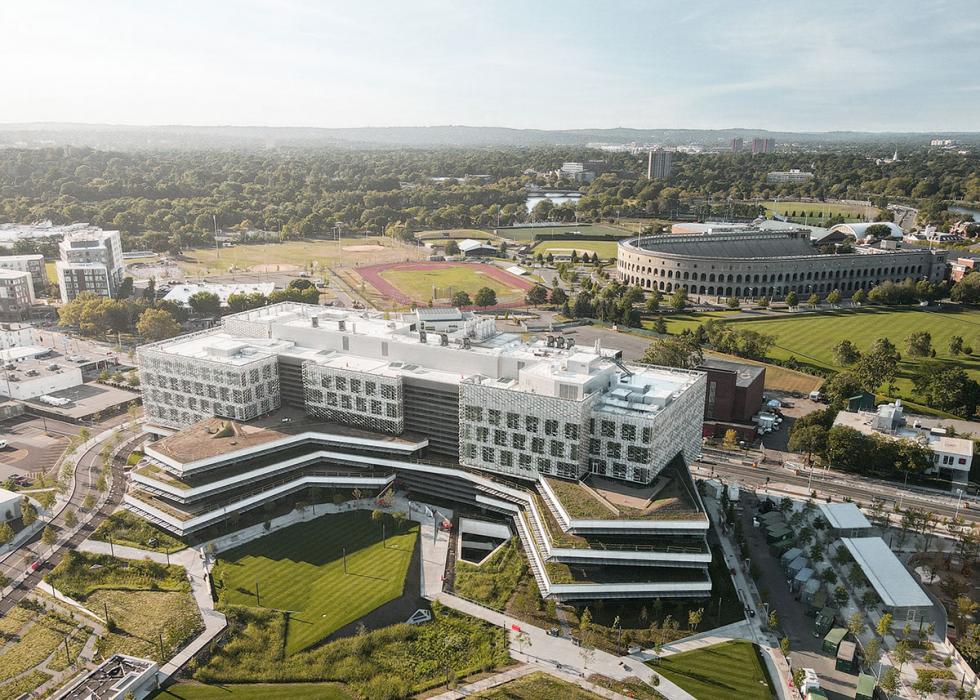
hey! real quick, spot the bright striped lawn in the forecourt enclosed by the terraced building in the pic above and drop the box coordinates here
[215,510,418,654]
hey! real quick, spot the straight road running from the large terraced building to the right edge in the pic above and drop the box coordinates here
[691,454,980,522]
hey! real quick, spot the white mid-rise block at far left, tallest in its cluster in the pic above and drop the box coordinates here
[55,229,123,304]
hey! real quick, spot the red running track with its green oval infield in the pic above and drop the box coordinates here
[357,262,534,308]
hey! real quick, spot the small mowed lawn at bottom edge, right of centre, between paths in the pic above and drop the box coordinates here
[650,640,775,700]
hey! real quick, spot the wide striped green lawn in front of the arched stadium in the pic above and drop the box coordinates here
[731,307,980,400]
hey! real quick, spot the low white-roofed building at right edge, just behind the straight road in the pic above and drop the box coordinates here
[834,399,973,489]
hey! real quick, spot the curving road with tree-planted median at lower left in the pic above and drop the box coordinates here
[0,426,146,614]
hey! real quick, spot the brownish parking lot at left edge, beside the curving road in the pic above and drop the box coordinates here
[0,417,79,481]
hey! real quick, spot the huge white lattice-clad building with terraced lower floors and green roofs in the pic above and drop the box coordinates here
[125,302,711,599]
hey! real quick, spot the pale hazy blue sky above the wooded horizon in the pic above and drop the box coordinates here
[0,0,980,131]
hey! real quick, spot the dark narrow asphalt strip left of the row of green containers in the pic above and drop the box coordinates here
[740,492,857,700]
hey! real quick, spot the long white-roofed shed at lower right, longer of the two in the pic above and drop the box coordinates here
[841,537,935,627]
